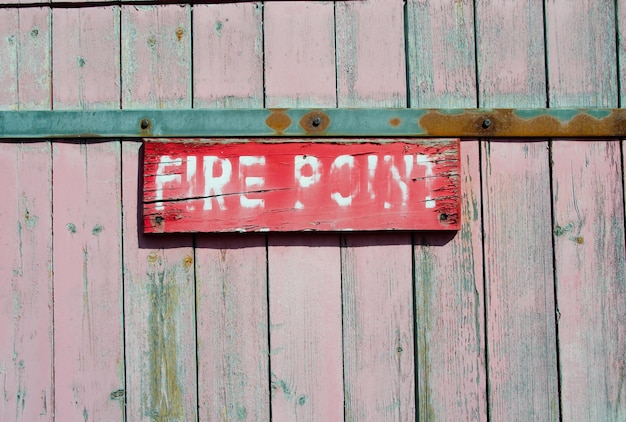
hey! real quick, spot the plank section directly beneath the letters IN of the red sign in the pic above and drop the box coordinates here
[341,233,415,421]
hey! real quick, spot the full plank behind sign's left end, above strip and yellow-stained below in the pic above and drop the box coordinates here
[122,5,197,421]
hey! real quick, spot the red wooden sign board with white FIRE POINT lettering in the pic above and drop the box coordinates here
[143,139,460,233]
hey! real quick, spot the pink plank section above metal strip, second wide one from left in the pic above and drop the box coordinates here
[52,6,120,110]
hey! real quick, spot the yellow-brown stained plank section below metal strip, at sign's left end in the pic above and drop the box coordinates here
[122,142,197,421]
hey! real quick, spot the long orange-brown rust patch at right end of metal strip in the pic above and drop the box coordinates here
[419,109,626,138]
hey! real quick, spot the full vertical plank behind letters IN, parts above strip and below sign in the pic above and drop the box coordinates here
[335,0,415,421]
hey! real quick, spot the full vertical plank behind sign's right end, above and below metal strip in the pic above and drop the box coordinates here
[407,0,487,421]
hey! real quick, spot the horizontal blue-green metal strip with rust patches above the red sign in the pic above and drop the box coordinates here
[0,108,626,139]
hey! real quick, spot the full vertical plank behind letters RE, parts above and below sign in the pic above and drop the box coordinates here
[193,4,270,421]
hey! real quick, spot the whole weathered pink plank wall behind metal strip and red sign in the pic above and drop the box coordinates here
[0,0,626,421]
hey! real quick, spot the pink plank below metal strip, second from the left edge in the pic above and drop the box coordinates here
[53,142,124,420]
